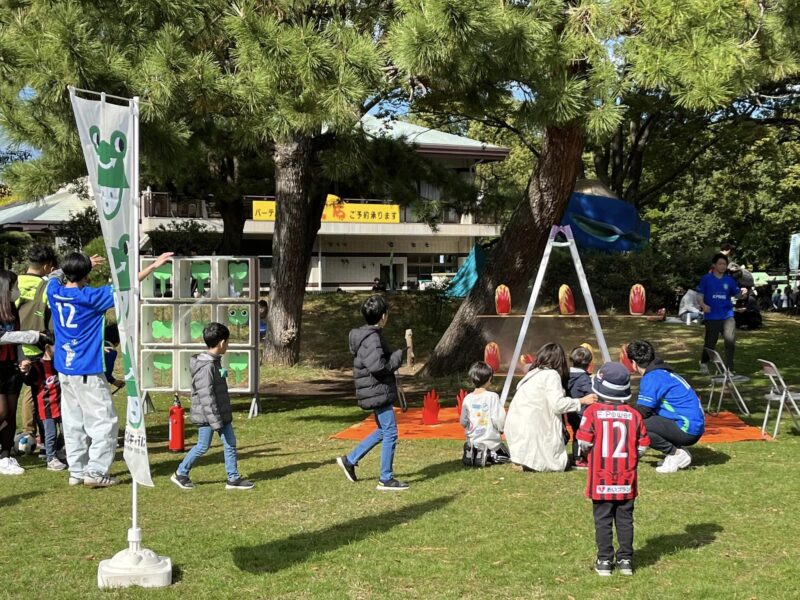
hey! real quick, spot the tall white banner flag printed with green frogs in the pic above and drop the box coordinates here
[70,88,153,486]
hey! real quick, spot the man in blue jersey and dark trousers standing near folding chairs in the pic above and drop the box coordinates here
[697,253,739,375]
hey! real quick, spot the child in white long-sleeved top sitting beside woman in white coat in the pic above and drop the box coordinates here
[459,361,508,466]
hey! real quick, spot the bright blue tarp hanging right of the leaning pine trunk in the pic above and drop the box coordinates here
[561,192,650,252]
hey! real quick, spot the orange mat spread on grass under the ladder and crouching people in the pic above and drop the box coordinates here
[331,406,770,444]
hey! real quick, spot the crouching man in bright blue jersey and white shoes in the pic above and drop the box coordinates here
[626,340,705,473]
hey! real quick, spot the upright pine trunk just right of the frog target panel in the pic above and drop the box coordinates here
[267,135,325,366]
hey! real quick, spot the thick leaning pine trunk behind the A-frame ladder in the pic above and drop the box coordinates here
[425,127,583,376]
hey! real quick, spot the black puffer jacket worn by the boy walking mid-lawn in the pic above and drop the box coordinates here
[349,325,403,410]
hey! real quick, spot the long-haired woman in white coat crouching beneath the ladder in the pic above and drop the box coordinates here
[505,344,596,471]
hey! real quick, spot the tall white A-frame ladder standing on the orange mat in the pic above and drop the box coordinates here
[500,225,611,403]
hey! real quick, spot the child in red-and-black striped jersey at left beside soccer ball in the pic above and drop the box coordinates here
[20,337,67,471]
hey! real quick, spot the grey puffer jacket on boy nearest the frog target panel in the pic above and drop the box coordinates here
[189,352,233,431]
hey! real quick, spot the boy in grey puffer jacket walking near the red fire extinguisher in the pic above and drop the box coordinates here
[170,323,254,490]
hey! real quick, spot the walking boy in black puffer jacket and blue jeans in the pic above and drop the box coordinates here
[336,296,408,492]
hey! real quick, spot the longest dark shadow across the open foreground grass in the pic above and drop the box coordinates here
[232,496,455,575]
